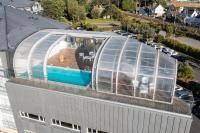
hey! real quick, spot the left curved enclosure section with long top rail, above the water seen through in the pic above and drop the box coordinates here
[13,29,111,80]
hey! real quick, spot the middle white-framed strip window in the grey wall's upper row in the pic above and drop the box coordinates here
[51,119,81,132]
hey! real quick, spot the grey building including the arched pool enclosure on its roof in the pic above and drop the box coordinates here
[6,29,192,133]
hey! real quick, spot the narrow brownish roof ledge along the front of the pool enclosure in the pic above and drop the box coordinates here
[8,78,191,116]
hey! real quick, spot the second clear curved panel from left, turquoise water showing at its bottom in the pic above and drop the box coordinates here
[31,34,62,79]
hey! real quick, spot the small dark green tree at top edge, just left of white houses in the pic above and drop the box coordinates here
[122,0,136,12]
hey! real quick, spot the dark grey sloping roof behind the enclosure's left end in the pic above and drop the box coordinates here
[0,5,70,50]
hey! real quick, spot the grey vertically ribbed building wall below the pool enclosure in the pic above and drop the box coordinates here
[7,82,192,133]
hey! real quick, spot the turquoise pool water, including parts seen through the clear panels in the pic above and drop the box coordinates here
[21,66,91,86]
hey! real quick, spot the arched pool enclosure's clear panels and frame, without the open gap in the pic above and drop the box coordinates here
[13,29,177,103]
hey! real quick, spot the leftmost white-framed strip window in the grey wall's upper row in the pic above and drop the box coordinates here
[20,112,45,122]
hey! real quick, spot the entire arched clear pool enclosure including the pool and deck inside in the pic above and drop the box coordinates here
[13,29,177,103]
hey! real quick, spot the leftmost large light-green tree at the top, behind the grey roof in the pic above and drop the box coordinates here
[41,0,65,20]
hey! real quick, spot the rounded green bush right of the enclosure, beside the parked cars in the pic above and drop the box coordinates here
[178,63,194,82]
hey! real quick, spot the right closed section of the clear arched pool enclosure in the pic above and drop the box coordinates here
[92,37,177,102]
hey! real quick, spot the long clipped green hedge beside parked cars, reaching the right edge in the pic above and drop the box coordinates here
[162,38,200,59]
